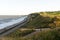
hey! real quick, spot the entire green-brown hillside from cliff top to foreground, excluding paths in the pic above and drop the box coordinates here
[2,11,60,40]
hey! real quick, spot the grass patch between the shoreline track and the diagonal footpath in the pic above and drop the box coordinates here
[0,29,35,40]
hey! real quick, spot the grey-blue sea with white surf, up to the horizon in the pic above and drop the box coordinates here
[0,15,25,29]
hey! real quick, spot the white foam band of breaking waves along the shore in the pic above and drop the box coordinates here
[0,16,27,29]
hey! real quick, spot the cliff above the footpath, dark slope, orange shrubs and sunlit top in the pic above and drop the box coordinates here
[26,12,60,28]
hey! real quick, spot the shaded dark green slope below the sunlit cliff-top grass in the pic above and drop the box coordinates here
[26,14,54,28]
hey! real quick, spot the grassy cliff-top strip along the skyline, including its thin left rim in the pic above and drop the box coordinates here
[32,11,60,17]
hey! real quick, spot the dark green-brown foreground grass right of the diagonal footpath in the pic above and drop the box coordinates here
[23,29,60,40]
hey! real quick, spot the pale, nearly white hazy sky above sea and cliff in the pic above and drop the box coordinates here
[0,0,60,15]
